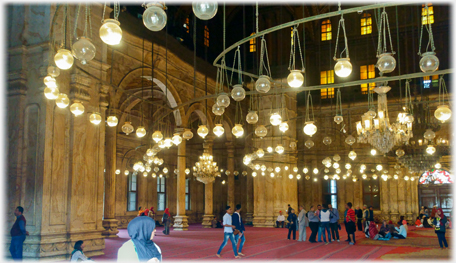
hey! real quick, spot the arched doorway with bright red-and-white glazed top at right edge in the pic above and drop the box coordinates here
[418,169,453,216]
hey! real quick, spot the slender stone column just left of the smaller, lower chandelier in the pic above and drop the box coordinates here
[173,128,188,230]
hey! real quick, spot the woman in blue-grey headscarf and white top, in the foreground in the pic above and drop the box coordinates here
[117,216,162,262]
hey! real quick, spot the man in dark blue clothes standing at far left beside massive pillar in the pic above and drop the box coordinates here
[10,206,29,260]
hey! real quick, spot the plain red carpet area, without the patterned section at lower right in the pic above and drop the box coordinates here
[93,224,448,261]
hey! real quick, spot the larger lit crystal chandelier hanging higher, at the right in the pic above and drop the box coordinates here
[356,86,413,154]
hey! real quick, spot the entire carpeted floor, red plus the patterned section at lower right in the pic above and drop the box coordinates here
[93,225,451,261]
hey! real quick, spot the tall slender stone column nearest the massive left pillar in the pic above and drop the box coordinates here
[103,110,119,238]
